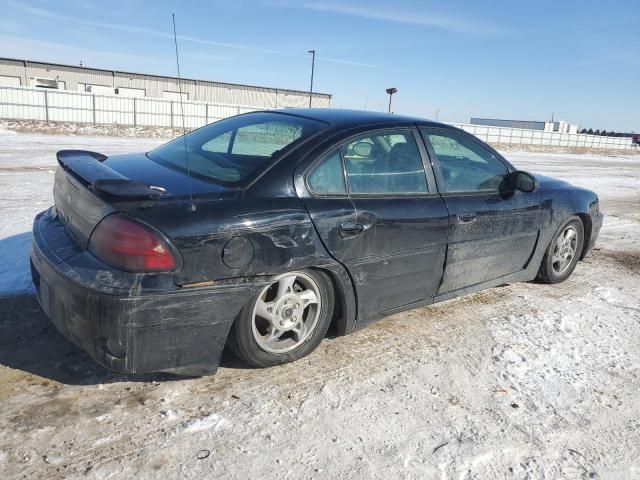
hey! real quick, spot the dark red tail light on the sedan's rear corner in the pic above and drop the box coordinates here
[88,214,177,272]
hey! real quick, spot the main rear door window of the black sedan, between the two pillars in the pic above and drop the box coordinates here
[342,132,428,195]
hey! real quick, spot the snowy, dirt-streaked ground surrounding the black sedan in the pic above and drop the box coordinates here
[0,133,640,479]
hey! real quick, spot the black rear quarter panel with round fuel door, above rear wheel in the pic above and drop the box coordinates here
[129,197,331,285]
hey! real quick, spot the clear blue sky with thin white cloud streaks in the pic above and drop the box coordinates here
[0,0,640,132]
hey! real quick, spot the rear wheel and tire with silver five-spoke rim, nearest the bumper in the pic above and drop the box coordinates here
[227,270,335,368]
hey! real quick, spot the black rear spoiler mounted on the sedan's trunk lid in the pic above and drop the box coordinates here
[56,150,166,198]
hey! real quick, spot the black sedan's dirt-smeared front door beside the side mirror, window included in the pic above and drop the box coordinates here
[421,128,541,294]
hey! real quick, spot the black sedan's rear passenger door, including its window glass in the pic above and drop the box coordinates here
[305,128,448,322]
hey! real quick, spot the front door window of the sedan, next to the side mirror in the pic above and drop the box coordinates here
[426,130,508,192]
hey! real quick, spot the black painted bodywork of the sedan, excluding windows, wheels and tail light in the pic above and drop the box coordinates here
[31,110,602,375]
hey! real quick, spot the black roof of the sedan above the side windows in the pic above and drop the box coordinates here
[270,108,450,128]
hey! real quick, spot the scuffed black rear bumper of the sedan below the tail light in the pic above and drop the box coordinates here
[30,208,266,375]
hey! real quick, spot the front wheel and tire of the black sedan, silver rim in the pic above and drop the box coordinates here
[537,216,584,283]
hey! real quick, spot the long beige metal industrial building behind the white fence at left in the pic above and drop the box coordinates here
[0,58,331,108]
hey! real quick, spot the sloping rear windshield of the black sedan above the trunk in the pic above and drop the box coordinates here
[147,113,327,183]
